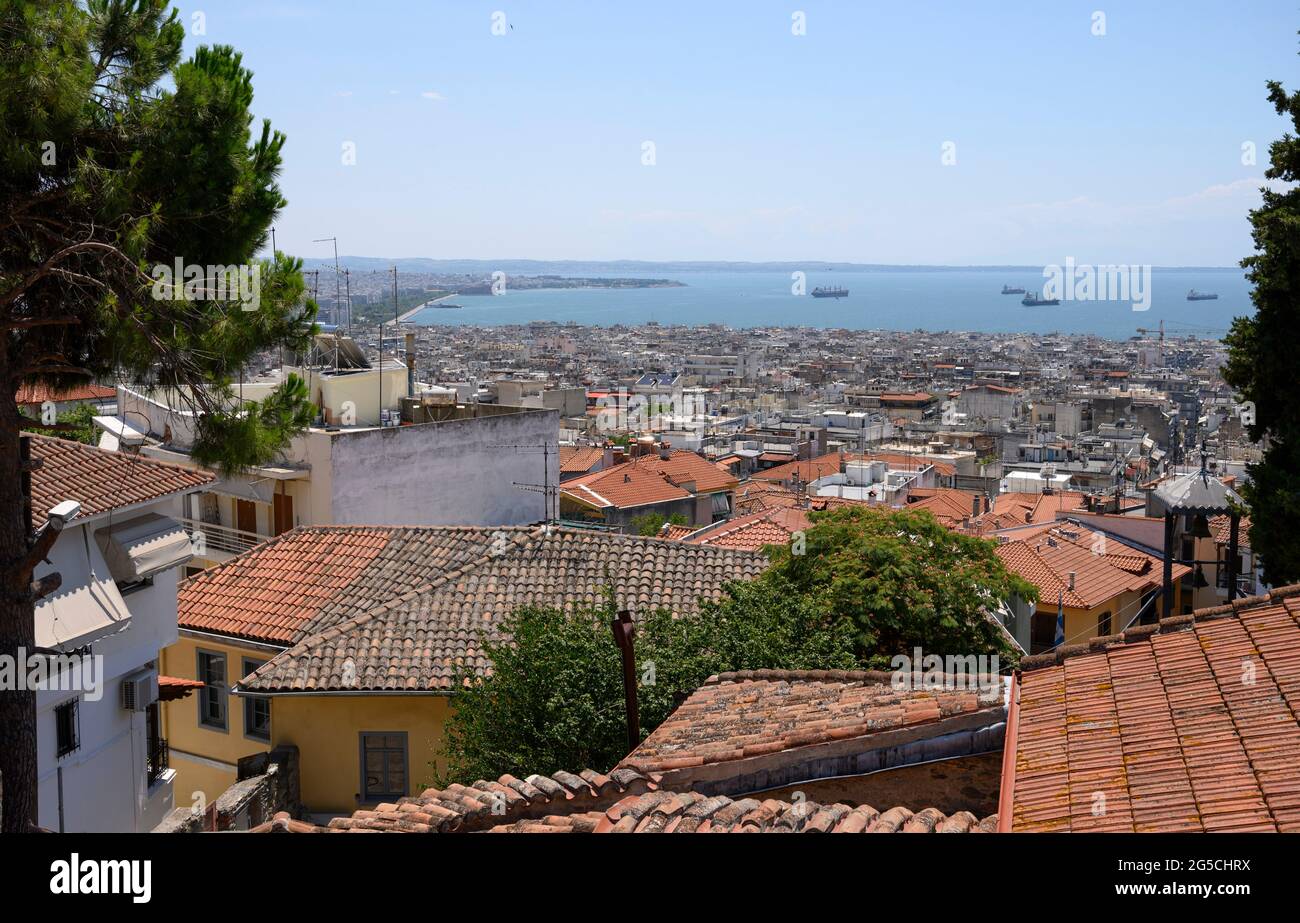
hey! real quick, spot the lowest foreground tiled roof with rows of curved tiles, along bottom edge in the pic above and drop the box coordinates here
[261,770,997,833]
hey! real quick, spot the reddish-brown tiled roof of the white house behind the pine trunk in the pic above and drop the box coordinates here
[30,436,216,528]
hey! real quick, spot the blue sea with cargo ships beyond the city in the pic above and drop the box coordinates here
[408,267,1253,339]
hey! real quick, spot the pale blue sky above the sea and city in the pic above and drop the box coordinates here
[177,0,1300,267]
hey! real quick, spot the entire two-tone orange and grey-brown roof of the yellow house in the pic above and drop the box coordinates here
[230,527,767,692]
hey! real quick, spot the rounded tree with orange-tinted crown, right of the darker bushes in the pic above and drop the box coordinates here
[761,507,1037,668]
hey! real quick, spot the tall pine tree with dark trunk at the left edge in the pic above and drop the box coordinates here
[0,0,316,832]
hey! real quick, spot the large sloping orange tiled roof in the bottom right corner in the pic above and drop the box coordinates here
[1001,586,1300,832]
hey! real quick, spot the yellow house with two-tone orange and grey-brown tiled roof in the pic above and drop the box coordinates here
[165,527,767,816]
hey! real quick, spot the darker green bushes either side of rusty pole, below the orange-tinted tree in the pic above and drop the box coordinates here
[438,580,855,780]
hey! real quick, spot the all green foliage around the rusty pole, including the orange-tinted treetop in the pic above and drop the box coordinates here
[442,508,1037,781]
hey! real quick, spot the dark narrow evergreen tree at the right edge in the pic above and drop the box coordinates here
[1223,81,1300,585]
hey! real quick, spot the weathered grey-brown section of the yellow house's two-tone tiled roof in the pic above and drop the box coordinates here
[235,527,767,692]
